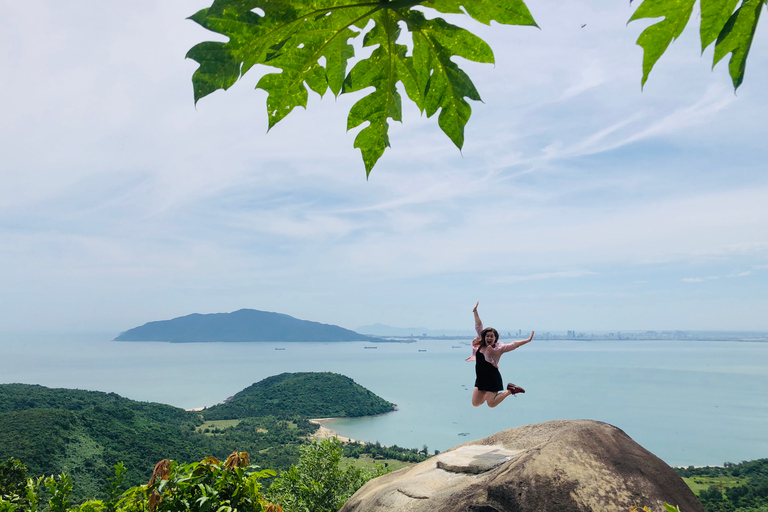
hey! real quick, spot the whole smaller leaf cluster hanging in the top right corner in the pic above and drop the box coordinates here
[629,0,765,88]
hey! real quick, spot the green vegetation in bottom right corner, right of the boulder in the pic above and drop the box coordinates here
[676,459,768,512]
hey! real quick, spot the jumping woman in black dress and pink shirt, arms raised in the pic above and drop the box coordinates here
[467,301,533,407]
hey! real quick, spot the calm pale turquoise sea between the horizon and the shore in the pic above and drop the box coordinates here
[0,333,768,465]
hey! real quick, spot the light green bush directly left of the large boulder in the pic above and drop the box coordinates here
[267,438,386,512]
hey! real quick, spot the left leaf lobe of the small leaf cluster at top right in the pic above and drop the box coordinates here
[629,0,695,85]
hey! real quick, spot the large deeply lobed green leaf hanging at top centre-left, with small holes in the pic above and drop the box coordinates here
[187,0,536,175]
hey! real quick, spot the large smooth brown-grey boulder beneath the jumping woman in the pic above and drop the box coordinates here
[340,420,704,512]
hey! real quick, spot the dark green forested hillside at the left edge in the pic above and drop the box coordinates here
[0,384,208,495]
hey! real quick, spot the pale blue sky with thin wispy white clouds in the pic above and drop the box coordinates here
[0,0,768,335]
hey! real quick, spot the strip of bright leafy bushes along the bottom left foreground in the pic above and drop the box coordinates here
[0,439,386,512]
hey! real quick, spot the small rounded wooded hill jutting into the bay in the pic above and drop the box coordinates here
[202,372,395,420]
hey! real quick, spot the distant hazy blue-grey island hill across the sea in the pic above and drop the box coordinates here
[115,309,380,343]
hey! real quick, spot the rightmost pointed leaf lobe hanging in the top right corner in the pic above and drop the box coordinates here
[712,0,764,89]
